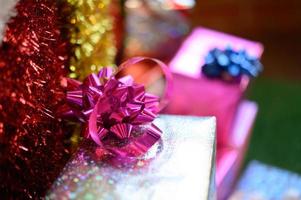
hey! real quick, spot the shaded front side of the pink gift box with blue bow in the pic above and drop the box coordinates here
[165,73,243,145]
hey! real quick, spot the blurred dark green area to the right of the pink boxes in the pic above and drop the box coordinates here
[246,78,301,174]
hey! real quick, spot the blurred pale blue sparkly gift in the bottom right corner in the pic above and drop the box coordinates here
[229,161,301,200]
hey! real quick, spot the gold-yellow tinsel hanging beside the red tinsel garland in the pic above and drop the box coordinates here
[67,0,116,79]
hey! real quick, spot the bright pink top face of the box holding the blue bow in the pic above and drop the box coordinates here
[169,27,263,78]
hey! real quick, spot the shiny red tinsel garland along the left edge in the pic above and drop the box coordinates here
[0,0,70,199]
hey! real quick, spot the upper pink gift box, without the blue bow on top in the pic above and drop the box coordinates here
[165,28,263,144]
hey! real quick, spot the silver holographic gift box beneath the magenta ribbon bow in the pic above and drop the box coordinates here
[46,115,215,200]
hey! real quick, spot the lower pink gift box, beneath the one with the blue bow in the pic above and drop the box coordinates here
[216,101,258,200]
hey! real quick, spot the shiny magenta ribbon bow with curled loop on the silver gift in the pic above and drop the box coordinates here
[63,57,171,162]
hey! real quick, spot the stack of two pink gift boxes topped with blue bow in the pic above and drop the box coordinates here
[166,28,263,199]
